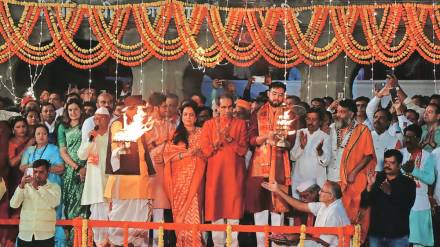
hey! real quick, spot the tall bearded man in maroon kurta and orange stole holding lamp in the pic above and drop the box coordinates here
[246,82,294,246]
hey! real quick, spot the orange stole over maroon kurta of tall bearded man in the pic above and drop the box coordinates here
[250,103,291,212]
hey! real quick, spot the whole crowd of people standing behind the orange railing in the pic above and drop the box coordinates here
[0,76,440,246]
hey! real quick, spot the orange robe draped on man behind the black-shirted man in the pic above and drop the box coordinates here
[340,124,376,239]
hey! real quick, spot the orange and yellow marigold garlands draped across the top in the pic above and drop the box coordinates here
[0,0,440,69]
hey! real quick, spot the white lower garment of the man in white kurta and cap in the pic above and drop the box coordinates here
[90,202,110,247]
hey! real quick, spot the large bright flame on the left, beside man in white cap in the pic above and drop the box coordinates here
[113,106,154,142]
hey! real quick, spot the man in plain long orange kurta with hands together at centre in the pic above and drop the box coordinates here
[201,95,248,246]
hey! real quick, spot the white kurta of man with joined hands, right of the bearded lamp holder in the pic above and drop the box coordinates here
[290,128,332,191]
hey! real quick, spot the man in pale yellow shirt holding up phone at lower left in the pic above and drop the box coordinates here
[10,159,61,247]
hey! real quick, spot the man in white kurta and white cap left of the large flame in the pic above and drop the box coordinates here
[78,107,110,246]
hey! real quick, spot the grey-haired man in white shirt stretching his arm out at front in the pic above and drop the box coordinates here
[262,181,350,247]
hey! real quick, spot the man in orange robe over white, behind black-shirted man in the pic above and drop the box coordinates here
[327,100,376,241]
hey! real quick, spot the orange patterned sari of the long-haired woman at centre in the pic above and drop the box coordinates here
[163,137,205,246]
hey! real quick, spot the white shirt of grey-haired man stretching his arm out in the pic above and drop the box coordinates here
[308,199,350,247]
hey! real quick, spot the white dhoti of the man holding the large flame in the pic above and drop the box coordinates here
[109,199,153,246]
